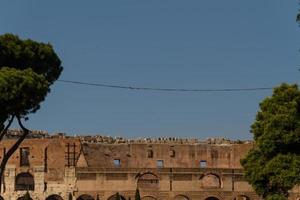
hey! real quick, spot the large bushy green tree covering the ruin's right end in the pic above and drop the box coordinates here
[241,84,300,200]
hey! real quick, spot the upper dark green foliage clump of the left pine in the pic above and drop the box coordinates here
[0,34,63,84]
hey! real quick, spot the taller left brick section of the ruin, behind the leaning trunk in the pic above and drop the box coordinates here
[0,138,81,200]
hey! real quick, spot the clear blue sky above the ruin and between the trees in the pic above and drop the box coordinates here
[0,0,300,139]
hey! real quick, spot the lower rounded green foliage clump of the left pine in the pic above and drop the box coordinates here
[0,67,49,116]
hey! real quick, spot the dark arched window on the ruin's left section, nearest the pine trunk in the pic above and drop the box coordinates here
[15,173,34,191]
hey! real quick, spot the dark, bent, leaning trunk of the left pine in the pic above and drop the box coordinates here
[0,116,30,193]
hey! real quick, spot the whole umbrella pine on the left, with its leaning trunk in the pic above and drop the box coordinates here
[0,34,63,189]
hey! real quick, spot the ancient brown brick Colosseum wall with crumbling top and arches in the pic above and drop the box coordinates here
[0,131,300,200]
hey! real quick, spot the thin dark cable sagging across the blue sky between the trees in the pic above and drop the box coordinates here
[58,79,273,92]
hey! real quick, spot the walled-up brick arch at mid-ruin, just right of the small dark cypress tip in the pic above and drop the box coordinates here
[137,172,159,190]
